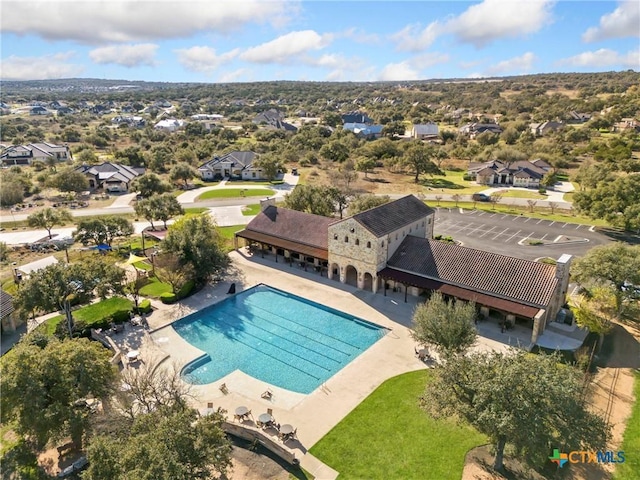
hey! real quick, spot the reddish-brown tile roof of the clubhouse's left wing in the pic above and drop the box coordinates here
[246,206,336,250]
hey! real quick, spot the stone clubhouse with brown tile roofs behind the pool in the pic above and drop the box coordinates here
[235,195,571,344]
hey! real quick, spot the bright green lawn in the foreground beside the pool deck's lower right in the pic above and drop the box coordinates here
[310,370,487,480]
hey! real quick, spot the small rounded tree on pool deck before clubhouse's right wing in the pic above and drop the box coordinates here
[411,292,477,355]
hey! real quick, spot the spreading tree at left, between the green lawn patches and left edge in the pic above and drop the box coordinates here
[14,258,125,336]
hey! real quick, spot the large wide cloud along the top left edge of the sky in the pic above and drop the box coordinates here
[0,0,295,44]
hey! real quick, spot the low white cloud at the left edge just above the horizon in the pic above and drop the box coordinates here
[0,52,84,80]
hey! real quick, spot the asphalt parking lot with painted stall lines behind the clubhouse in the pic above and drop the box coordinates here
[435,208,610,260]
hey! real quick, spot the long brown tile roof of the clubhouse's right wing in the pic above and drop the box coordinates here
[387,236,558,307]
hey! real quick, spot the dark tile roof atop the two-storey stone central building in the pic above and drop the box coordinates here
[351,195,434,238]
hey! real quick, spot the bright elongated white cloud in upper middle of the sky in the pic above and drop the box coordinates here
[240,30,332,64]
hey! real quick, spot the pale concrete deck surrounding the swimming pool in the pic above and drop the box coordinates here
[141,249,528,478]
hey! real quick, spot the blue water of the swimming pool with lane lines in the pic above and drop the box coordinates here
[173,285,387,393]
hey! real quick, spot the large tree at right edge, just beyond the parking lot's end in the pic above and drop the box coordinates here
[573,173,640,230]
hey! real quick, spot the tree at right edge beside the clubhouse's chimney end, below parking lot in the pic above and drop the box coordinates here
[571,242,640,316]
